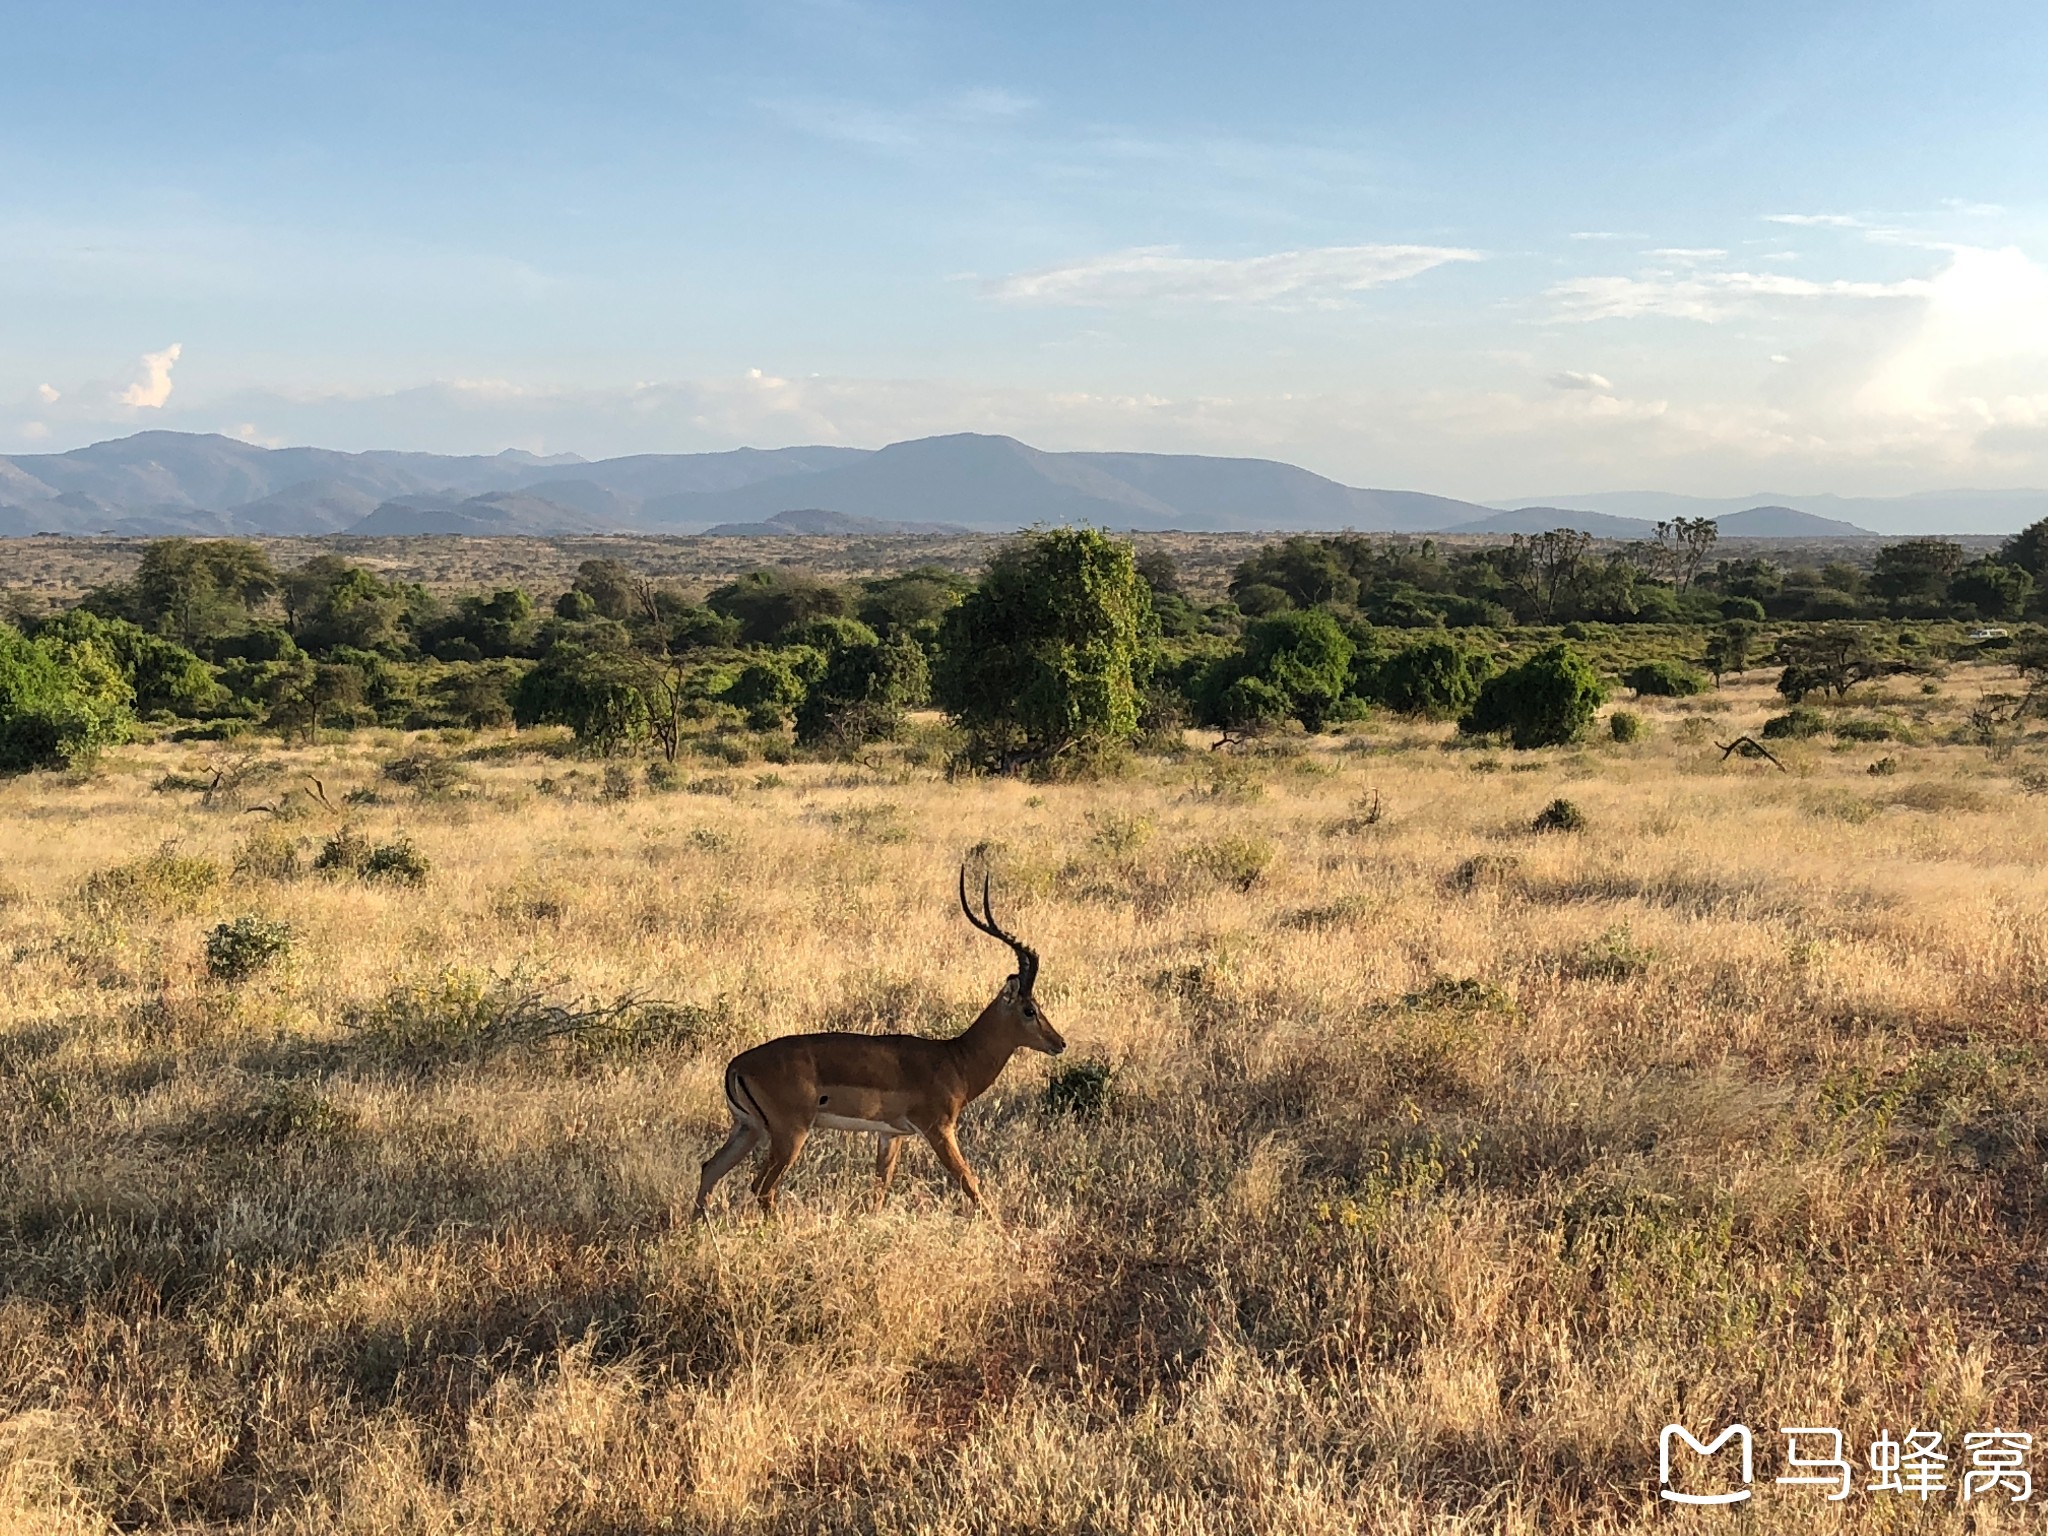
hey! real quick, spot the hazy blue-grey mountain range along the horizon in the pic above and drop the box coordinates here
[0,432,2048,539]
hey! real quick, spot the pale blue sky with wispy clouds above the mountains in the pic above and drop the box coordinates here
[0,0,2048,498]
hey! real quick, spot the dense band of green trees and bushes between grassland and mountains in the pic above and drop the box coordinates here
[0,520,2048,770]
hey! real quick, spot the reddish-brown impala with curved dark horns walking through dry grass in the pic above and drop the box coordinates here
[696,868,1067,1221]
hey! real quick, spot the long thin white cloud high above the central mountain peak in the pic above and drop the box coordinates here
[983,246,1481,307]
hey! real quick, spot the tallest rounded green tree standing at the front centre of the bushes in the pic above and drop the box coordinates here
[932,528,1159,766]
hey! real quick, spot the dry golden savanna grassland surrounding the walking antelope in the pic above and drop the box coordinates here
[12,666,2048,1534]
